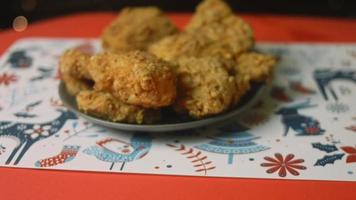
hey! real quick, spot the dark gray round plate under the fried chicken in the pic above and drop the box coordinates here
[59,82,265,132]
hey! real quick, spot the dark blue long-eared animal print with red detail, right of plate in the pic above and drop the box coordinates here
[276,99,325,136]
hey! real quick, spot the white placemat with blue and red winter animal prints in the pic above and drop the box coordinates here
[0,38,356,181]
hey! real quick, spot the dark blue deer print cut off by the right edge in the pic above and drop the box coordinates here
[314,69,356,101]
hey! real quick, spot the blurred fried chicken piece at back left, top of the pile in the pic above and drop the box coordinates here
[101,7,178,52]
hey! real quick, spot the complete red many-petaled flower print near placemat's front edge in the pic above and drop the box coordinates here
[261,153,307,177]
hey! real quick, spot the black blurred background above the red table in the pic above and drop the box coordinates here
[0,0,356,29]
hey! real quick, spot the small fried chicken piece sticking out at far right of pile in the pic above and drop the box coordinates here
[235,52,277,82]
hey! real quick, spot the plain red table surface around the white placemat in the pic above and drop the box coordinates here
[0,13,356,200]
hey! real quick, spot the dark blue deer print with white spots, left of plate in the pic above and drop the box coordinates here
[0,109,77,165]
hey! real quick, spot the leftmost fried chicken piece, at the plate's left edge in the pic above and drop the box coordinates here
[59,50,93,95]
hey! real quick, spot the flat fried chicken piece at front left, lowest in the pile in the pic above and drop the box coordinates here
[76,90,160,124]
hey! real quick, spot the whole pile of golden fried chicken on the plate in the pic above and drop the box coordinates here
[59,0,276,124]
